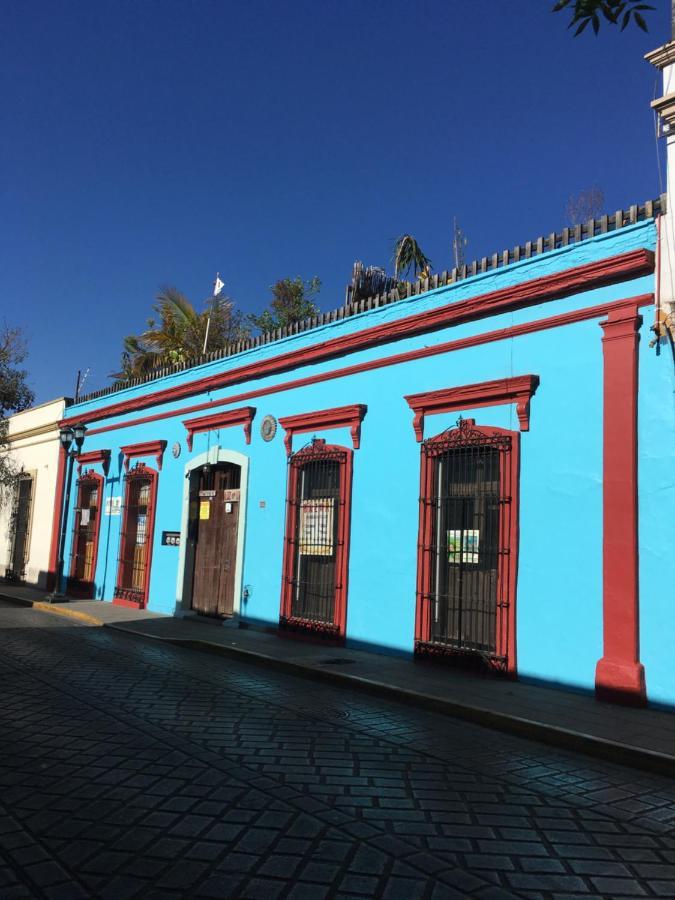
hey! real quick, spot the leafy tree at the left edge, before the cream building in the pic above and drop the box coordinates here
[0,325,34,505]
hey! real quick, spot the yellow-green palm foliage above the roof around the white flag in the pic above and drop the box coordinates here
[113,287,250,381]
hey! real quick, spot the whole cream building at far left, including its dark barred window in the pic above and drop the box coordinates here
[0,397,71,589]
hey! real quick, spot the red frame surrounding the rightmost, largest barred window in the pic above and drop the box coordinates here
[415,419,520,677]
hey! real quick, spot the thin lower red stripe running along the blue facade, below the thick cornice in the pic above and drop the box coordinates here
[80,294,654,435]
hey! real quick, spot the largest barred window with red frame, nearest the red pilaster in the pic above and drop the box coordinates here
[417,420,513,669]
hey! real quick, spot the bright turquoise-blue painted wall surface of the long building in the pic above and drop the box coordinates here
[58,223,675,702]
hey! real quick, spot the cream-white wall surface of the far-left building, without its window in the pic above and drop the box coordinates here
[0,397,66,588]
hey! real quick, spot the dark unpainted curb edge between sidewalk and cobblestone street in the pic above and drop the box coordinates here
[105,622,675,778]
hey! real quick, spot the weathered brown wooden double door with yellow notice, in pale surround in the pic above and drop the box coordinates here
[189,463,241,618]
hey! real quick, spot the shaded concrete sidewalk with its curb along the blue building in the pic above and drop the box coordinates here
[0,585,675,776]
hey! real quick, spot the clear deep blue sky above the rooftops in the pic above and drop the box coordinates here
[0,0,670,402]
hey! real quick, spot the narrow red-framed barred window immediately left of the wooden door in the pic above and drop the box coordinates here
[115,463,157,607]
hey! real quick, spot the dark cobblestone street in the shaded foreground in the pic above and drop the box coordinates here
[0,602,675,900]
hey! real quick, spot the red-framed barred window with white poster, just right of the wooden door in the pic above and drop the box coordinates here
[281,440,352,637]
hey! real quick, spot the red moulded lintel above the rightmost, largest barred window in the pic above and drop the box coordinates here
[403,375,539,441]
